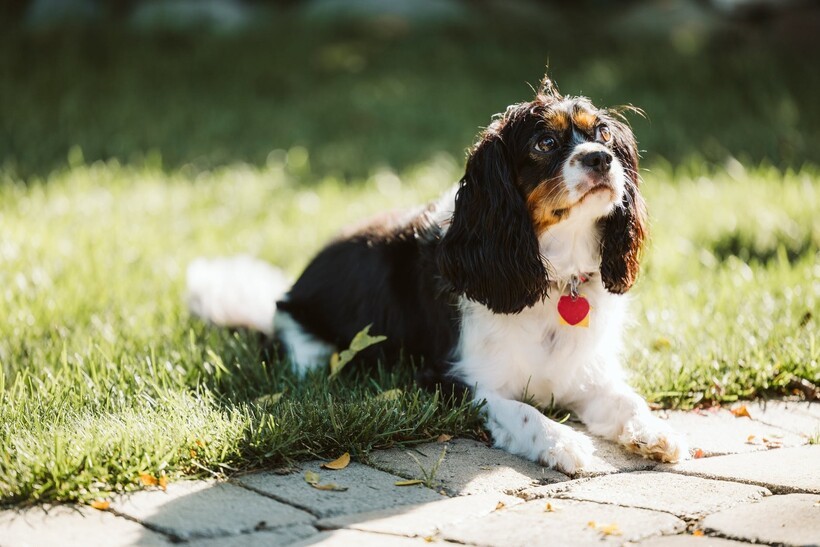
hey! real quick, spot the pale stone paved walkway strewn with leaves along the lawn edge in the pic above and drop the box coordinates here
[0,402,820,547]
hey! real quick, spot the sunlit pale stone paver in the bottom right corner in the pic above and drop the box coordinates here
[703,494,820,545]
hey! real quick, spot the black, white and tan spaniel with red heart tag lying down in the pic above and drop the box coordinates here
[188,77,689,474]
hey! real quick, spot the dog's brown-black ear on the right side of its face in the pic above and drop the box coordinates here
[601,120,647,294]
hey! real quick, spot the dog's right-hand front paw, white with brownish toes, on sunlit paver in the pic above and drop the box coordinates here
[618,414,689,463]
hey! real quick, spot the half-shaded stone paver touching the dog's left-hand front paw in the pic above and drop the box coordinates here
[370,439,569,495]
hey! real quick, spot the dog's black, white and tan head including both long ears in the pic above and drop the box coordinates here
[437,74,646,313]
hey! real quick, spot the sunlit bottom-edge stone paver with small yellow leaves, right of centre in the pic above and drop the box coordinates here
[440,499,686,547]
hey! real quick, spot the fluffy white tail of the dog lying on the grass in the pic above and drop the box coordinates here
[186,255,289,336]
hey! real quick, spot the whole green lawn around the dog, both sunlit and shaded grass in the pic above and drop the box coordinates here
[0,10,820,504]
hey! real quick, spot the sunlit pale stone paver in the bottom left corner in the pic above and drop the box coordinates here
[0,505,171,547]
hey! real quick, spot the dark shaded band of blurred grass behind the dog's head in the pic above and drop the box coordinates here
[0,0,820,178]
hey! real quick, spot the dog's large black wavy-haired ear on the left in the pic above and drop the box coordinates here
[436,130,549,313]
